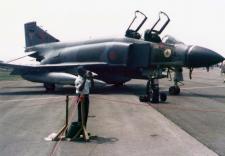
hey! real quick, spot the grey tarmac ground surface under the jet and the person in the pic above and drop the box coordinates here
[0,70,222,156]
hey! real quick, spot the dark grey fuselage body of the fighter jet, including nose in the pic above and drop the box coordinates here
[23,38,224,84]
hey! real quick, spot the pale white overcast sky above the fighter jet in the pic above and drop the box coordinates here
[0,0,225,62]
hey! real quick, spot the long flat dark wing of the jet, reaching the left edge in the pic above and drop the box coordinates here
[0,62,107,75]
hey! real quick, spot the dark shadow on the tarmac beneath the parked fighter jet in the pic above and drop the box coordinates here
[0,83,221,99]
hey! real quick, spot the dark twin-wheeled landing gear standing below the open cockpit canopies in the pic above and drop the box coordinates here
[139,78,167,103]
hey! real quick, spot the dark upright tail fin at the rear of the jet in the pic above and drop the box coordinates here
[24,22,59,47]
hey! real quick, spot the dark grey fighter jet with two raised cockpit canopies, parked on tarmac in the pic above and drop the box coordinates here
[0,11,224,102]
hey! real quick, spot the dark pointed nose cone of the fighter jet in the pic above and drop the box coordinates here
[187,46,224,67]
